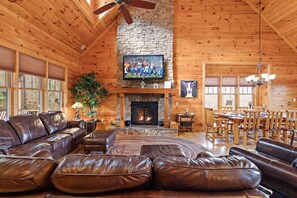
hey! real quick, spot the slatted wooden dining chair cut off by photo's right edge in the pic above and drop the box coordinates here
[283,110,297,145]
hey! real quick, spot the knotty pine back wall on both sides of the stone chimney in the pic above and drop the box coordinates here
[83,0,297,131]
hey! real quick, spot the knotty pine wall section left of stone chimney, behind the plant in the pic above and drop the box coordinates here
[82,23,118,129]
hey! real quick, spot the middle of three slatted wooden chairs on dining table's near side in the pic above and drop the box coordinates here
[264,110,283,141]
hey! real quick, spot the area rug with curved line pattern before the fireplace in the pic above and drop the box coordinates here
[107,135,208,158]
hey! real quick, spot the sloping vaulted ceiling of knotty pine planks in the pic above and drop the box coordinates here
[0,0,297,53]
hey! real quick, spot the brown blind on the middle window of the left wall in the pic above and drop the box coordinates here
[20,53,45,77]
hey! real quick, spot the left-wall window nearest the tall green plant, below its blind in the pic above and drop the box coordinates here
[48,79,63,111]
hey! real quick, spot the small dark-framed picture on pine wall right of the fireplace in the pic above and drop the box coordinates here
[180,80,198,98]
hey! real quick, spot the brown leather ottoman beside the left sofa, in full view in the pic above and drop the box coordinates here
[83,130,116,153]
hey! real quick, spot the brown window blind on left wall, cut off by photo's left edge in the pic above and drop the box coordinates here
[0,46,15,72]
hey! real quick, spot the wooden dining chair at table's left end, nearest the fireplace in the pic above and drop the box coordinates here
[205,108,229,144]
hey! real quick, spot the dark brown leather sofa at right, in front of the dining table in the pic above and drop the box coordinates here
[229,138,297,197]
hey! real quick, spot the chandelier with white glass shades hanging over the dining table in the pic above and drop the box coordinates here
[245,0,276,86]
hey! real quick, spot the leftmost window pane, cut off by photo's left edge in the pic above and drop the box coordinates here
[0,70,11,120]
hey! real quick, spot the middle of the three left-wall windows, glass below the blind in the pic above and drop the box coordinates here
[18,74,43,115]
